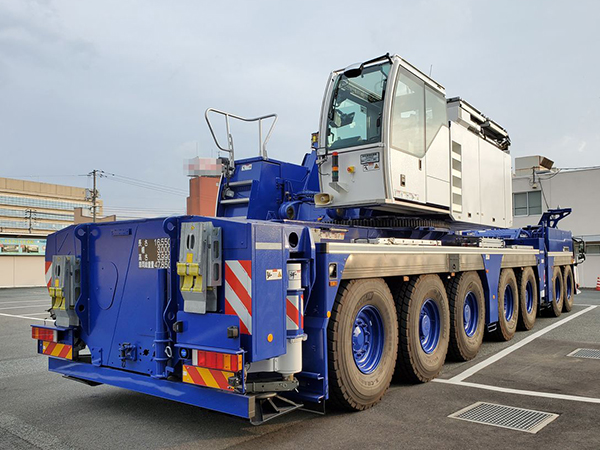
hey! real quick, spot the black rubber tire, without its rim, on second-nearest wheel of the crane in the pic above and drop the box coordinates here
[394,275,450,383]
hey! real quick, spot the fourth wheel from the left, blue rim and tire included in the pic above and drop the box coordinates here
[494,269,519,341]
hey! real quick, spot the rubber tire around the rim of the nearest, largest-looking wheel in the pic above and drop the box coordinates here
[327,278,398,411]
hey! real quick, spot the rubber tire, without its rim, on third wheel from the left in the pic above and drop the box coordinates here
[446,272,485,361]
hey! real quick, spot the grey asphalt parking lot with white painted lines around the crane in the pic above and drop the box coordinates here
[0,288,600,450]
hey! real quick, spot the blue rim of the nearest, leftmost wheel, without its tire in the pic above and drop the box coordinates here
[352,305,384,374]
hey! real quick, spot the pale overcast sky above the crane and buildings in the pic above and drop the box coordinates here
[0,0,600,217]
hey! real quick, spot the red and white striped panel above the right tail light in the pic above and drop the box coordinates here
[225,260,252,334]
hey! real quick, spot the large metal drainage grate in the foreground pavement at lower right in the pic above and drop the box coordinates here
[448,402,558,433]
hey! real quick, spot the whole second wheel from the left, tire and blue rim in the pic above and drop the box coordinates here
[395,275,450,382]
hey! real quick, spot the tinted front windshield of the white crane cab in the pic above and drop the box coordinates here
[327,63,391,150]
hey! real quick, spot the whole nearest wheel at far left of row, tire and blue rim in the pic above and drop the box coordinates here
[327,278,398,410]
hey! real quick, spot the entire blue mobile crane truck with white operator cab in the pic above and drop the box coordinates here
[32,54,576,424]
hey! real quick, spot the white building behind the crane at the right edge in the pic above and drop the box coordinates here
[513,156,600,288]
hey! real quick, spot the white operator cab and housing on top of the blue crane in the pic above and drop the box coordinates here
[315,55,512,228]
